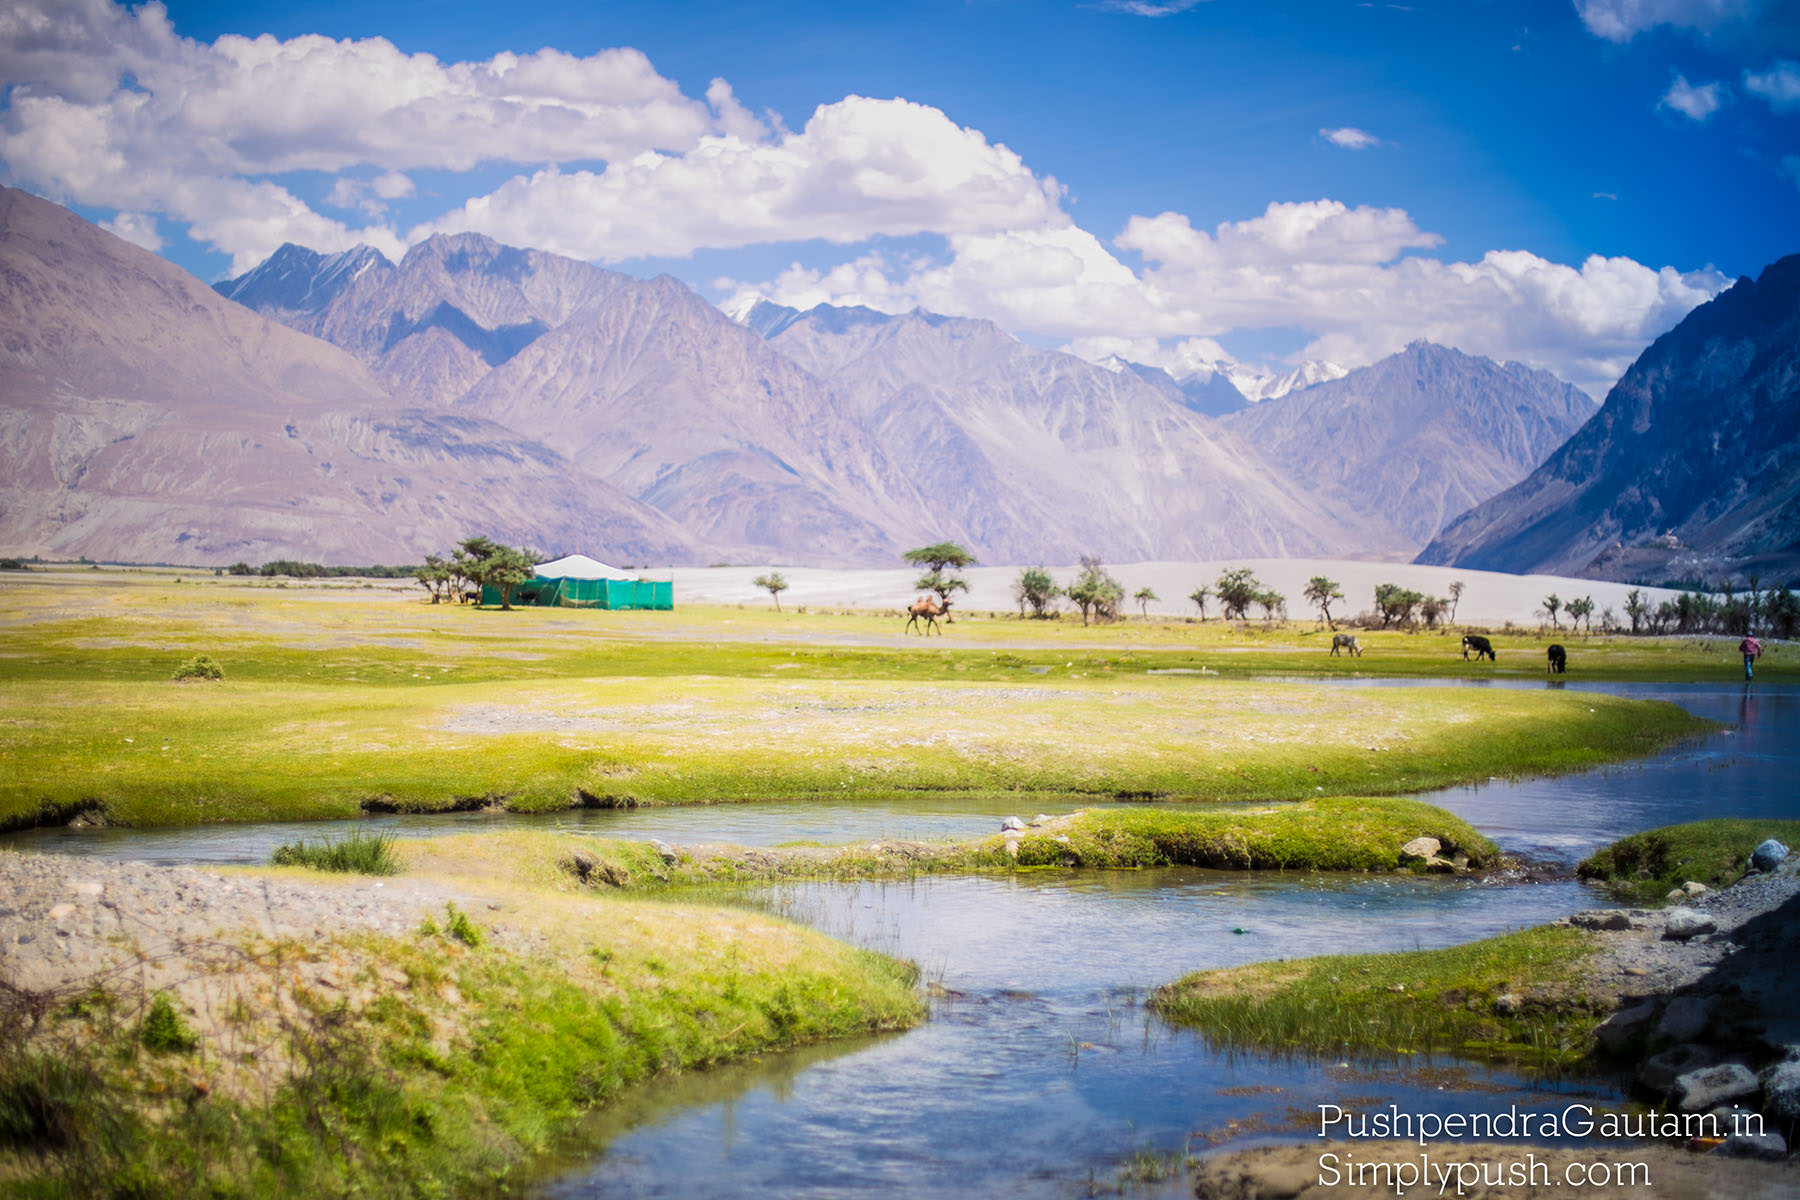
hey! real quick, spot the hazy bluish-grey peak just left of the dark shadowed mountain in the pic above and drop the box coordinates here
[1226,342,1595,545]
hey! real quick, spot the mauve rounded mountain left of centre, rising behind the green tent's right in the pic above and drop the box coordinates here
[457,286,929,561]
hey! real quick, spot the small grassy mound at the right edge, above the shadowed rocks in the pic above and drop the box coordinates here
[1577,819,1800,905]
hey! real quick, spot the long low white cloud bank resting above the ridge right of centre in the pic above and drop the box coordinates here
[720,200,1728,394]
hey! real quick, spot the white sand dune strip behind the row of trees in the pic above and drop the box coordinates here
[657,558,1674,626]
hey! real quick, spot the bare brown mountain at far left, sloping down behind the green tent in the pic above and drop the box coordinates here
[0,189,693,563]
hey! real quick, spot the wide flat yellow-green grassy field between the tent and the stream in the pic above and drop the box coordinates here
[0,572,1706,828]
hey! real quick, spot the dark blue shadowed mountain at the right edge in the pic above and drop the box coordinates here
[1418,255,1800,581]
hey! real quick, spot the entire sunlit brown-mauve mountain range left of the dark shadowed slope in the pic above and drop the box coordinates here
[0,191,1634,563]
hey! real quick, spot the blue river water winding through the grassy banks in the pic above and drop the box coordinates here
[9,680,1800,1200]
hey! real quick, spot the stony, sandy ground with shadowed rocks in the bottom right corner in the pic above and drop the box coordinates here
[1193,867,1800,1200]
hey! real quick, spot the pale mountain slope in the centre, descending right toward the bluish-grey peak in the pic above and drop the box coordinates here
[745,306,1391,561]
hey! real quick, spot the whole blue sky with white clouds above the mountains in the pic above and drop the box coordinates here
[0,0,1800,390]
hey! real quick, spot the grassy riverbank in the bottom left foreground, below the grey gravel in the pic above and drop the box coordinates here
[0,881,922,1200]
